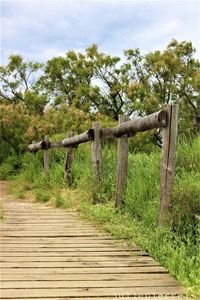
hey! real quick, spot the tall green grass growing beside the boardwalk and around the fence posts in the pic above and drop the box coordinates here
[1,136,200,297]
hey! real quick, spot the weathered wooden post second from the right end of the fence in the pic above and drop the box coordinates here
[115,115,129,207]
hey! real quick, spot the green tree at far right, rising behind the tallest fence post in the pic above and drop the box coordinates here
[125,40,200,131]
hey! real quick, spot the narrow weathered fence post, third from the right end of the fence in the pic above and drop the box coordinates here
[92,122,102,202]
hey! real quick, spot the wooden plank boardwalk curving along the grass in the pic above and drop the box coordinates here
[0,199,187,300]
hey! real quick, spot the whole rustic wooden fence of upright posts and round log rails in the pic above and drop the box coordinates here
[28,104,178,225]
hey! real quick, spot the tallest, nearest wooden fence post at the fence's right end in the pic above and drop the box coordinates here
[159,104,178,226]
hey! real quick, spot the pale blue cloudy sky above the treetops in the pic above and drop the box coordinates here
[0,0,200,65]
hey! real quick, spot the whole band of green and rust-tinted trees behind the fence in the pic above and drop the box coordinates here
[0,40,200,162]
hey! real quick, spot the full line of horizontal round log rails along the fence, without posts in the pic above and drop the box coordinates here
[28,109,167,152]
